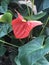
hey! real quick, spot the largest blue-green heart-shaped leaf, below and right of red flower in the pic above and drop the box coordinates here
[15,36,49,65]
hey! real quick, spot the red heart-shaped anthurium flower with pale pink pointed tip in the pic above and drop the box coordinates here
[12,12,42,39]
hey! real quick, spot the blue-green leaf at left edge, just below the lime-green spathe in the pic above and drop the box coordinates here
[0,23,12,38]
